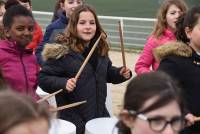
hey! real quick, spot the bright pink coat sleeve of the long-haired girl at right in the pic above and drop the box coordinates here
[134,37,157,74]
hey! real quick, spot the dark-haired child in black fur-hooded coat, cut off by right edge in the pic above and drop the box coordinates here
[155,6,200,134]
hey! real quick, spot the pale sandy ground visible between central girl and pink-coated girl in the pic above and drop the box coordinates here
[109,51,138,115]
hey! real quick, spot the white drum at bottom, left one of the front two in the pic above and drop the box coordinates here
[49,119,76,134]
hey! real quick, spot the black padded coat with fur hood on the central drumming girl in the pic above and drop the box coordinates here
[39,45,130,134]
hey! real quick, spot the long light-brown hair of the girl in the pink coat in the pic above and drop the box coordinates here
[152,0,187,38]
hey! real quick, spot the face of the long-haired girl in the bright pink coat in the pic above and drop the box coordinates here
[166,5,182,30]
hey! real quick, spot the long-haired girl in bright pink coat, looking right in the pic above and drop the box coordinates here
[135,0,187,74]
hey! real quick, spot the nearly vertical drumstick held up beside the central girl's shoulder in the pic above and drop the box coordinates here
[119,21,126,68]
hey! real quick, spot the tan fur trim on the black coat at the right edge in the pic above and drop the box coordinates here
[153,41,192,61]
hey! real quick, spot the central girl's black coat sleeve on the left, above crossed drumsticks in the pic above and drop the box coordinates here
[39,61,69,93]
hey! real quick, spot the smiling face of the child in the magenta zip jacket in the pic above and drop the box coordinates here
[5,16,34,47]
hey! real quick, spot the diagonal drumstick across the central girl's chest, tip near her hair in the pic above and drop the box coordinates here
[75,34,101,80]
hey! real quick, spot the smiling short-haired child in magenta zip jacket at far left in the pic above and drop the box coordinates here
[0,5,39,100]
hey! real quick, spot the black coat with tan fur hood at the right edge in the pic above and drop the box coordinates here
[156,43,200,134]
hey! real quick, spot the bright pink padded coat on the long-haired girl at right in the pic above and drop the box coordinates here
[135,29,176,74]
